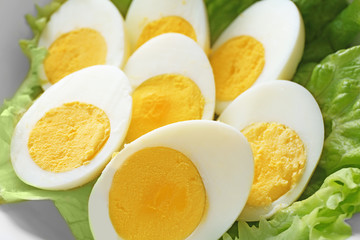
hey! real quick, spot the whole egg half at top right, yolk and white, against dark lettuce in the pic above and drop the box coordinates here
[210,0,305,114]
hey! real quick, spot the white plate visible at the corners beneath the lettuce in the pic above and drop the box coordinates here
[0,0,360,240]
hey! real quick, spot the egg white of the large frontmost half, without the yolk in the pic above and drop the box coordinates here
[89,120,254,240]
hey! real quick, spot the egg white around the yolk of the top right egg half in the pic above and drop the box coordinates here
[212,0,305,114]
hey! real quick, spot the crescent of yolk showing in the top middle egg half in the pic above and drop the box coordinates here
[136,16,196,48]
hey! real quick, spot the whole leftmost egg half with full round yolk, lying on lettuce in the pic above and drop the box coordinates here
[11,66,132,190]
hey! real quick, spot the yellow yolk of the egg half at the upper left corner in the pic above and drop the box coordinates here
[44,28,107,84]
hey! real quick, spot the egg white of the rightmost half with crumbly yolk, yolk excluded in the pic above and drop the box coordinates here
[219,80,324,221]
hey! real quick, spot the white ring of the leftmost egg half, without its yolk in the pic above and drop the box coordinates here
[11,65,132,190]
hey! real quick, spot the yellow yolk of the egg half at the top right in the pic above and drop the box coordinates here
[210,36,265,101]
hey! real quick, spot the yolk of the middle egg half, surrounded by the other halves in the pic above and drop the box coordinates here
[126,74,205,142]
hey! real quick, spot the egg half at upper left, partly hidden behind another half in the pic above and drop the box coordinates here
[38,0,128,89]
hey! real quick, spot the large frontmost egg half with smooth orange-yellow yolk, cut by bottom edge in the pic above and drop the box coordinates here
[89,120,253,240]
